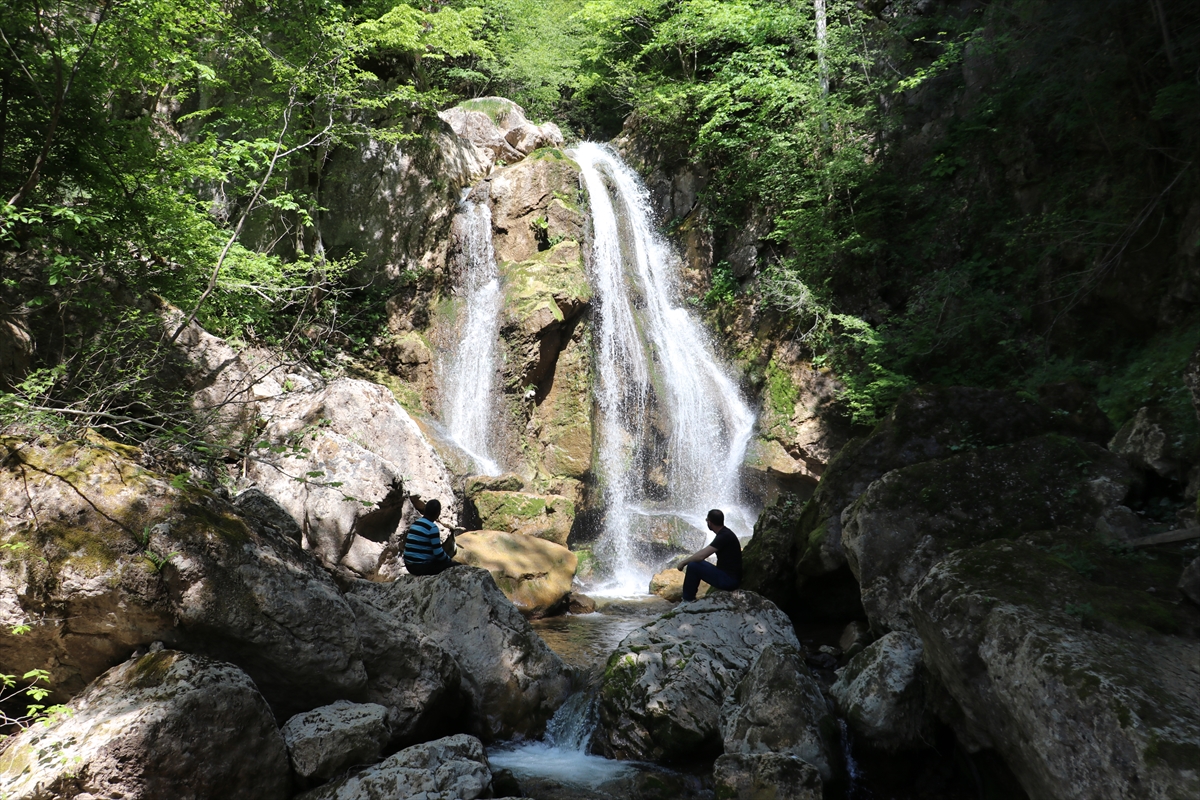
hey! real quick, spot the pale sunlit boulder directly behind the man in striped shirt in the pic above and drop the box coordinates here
[246,378,461,577]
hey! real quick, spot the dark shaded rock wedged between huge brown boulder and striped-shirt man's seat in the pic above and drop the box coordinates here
[346,593,462,745]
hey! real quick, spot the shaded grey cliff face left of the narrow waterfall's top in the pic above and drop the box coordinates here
[320,120,492,281]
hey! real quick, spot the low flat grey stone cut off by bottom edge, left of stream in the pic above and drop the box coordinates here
[296,734,492,800]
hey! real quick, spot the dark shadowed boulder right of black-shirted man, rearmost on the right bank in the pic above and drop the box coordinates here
[742,386,1099,613]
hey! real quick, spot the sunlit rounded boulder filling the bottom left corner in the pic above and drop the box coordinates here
[0,650,292,800]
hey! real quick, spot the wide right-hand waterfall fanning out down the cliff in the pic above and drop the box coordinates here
[572,143,755,593]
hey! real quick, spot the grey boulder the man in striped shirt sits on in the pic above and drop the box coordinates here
[350,566,570,741]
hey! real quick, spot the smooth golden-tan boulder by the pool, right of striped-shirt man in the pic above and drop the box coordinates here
[455,530,578,616]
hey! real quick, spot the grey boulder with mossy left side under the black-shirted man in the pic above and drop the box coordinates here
[594,591,799,760]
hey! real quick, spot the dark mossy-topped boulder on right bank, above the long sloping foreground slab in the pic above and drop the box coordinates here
[841,434,1133,631]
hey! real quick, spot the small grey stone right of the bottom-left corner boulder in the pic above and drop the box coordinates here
[281,700,391,781]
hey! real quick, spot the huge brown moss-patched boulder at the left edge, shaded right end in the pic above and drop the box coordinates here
[0,438,366,714]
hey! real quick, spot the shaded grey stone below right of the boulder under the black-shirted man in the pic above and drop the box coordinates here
[721,644,838,781]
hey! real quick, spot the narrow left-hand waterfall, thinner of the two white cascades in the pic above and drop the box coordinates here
[442,200,502,475]
